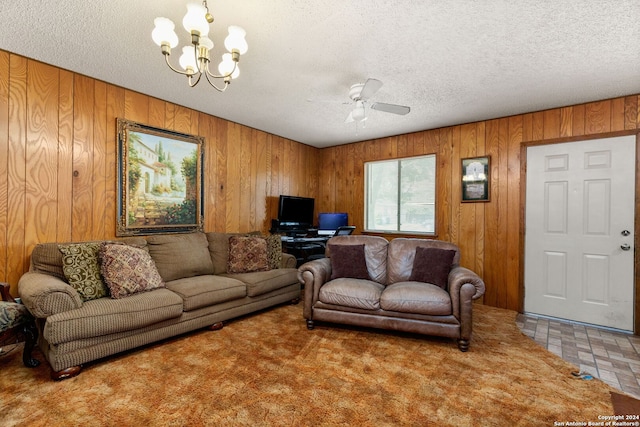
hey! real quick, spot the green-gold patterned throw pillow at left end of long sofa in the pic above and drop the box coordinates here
[58,242,109,301]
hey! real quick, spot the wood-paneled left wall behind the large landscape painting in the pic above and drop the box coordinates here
[0,51,320,295]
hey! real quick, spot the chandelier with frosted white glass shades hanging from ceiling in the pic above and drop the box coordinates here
[151,0,248,92]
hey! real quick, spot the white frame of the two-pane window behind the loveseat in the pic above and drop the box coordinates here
[364,154,437,236]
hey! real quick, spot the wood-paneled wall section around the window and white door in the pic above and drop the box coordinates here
[319,95,640,310]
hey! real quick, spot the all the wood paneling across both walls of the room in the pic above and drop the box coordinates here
[0,50,640,310]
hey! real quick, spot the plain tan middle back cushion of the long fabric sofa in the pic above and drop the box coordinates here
[147,232,213,282]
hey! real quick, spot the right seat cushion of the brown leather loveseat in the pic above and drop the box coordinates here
[380,282,452,316]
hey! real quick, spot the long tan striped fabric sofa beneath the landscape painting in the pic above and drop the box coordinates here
[18,233,300,379]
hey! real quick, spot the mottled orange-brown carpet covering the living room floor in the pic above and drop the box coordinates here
[0,305,628,427]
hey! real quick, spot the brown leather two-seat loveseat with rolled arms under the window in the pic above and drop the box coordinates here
[298,236,485,351]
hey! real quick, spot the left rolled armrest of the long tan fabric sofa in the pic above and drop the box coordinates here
[18,272,82,318]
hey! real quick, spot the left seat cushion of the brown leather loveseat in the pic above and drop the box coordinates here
[318,278,384,310]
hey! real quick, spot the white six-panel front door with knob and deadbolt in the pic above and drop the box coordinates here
[524,136,636,331]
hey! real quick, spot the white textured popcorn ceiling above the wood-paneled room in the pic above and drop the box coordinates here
[0,0,640,147]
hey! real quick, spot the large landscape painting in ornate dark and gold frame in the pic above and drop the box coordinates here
[116,119,204,236]
